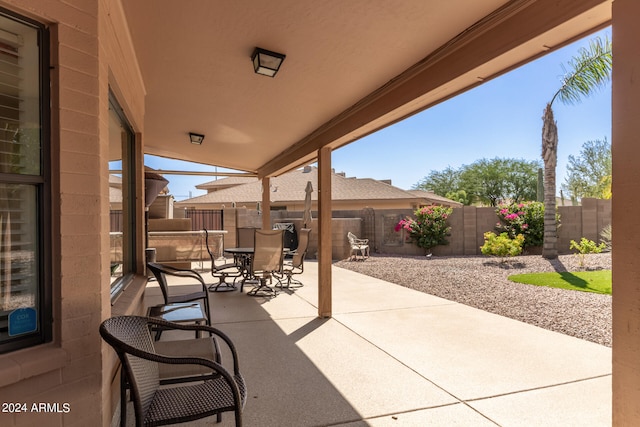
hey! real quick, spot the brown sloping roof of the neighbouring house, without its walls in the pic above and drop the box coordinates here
[176,166,456,205]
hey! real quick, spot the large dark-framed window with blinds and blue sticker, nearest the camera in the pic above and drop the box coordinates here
[0,9,52,353]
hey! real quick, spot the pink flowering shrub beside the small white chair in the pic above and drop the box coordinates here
[395,206,453,250]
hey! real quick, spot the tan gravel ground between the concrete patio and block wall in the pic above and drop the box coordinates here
[335,253,612,347]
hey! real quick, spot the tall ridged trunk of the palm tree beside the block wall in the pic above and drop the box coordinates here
[542,103,558,259]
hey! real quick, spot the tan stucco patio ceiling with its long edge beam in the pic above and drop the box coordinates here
[122,0,612,176]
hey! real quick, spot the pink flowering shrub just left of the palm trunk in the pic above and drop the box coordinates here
[496,202,544,247]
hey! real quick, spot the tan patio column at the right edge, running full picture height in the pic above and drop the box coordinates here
[611,0,640,426]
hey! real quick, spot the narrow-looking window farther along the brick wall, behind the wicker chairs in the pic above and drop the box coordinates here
[109,95,136,303]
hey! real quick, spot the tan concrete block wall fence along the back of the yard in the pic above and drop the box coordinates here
[224,199,611,260]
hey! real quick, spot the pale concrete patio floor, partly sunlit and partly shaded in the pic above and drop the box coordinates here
[142,262,611,427]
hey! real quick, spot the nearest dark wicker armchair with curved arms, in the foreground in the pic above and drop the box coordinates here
[100,316,247,427]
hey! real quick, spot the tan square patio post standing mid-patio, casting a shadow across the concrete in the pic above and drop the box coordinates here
[318,147,332,317]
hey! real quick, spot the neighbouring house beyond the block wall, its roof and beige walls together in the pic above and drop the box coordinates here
[175,166,462,211]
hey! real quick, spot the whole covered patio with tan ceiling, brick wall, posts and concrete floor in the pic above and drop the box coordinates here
[0,0,640,427]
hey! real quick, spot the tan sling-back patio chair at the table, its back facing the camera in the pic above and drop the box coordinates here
[246,230,284,296]
